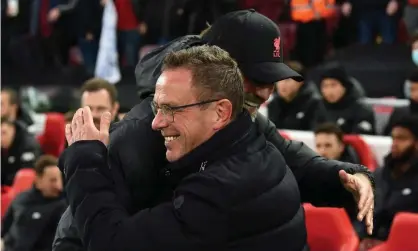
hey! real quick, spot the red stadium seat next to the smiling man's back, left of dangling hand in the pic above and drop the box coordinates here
[303,204,359,251]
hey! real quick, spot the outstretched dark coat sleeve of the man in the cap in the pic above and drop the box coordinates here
[257,114,374,210]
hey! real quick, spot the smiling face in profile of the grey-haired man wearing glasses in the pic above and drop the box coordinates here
[152,68,217,162]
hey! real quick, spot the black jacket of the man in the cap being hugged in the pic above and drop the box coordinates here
[53,98,367,251]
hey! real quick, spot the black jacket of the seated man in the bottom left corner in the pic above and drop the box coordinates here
[1,188,67,251]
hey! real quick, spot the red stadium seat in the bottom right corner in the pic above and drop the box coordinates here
[370,213,418,251]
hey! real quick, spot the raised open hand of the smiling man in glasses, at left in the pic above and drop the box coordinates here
[65,107,111,146]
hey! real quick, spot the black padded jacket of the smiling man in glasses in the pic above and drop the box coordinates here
[60,112,306,251]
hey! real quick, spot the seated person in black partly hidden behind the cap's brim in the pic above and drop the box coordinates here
[267,63,326,131]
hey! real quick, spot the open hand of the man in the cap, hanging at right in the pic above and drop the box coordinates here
[339,170,374,235]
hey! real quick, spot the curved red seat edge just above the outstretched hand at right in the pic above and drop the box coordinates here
[344,135,378,171]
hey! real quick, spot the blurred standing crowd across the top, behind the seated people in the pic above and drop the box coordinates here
[1,0,418,78]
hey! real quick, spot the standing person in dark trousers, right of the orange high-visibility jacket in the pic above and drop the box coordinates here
[341,0,401,44]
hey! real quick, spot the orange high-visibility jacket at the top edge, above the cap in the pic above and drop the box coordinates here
[290,0,336,23]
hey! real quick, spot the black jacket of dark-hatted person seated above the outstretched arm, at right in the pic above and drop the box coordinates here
[324,84,376,134]
